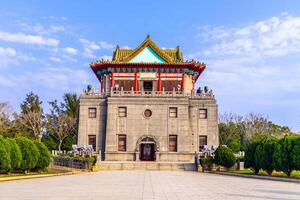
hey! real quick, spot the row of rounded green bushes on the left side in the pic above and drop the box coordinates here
[0,135,51,173]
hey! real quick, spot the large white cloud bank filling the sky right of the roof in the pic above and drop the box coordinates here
[192,14,300,129]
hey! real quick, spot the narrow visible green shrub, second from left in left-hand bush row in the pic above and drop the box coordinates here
[6,138,22,170]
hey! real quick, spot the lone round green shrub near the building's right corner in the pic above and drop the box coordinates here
[215,146,236,168]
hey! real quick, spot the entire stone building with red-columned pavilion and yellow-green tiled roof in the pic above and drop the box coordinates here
[78,36,219,164]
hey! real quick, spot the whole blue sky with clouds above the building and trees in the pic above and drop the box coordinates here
[0,0,300,131]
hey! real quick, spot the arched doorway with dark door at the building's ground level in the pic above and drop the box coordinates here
[136,136,158,161]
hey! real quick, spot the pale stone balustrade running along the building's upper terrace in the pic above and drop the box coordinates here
[82,88,215,99]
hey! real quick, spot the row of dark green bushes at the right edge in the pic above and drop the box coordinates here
[245,135,300,176]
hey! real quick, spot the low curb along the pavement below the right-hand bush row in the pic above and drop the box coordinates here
[210,172,300,183]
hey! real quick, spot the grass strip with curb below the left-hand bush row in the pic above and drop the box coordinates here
[0,168,68,181]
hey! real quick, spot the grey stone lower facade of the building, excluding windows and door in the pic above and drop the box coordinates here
[78,92,219,162]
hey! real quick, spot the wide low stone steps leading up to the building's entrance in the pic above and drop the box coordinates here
[97,161,194,171]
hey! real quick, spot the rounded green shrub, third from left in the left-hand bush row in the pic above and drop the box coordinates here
[16,137,40,172]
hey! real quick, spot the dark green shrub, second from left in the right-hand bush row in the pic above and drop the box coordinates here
[254,135,278,175]
